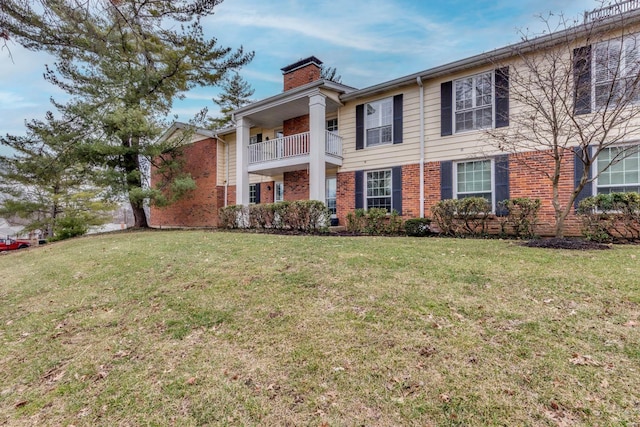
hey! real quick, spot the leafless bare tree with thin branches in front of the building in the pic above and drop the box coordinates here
[486,11,640,237]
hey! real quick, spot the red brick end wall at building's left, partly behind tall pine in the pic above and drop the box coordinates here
[150,138,224,227]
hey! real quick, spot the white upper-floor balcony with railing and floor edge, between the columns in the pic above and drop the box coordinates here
[249,131,342,175]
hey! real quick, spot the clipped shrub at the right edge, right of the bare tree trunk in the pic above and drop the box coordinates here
[578,193,640,242]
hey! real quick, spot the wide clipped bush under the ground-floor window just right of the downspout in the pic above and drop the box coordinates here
[431,197,491,236]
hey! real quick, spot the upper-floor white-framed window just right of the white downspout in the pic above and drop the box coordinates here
[453,72,493,132]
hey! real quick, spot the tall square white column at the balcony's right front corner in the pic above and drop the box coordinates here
[309,93,326,203]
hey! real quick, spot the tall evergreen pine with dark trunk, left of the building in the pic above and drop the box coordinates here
[0,0,253,227]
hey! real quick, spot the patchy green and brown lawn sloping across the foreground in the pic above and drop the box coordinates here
[0,231,640,426]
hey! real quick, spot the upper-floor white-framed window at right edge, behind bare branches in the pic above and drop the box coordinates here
[592,35,640,108]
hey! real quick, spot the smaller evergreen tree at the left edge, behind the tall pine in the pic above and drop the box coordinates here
[0,113,113,238]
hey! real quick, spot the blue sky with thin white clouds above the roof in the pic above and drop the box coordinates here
[0,0,601,154]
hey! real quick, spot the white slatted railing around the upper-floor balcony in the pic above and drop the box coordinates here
[249,131,342,165]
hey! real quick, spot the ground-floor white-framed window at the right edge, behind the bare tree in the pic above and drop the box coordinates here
[597,147,640,194]
